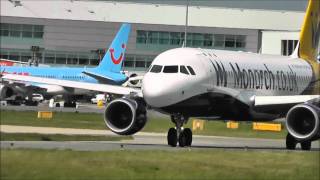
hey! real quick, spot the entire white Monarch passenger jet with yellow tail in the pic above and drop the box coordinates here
[4,0,320,150]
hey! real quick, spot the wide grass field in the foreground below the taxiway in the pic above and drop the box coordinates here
[0,149,320,180]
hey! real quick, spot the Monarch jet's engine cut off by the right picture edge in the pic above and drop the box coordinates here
[286,103,320,141]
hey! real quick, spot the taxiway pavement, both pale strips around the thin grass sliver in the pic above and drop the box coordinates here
[0,125,320,151]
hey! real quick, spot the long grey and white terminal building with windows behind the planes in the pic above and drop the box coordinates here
[0,0,307,73]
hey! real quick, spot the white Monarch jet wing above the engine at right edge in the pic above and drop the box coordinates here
[254,95,320,106]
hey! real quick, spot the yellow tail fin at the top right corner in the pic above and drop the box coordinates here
[298,0,320,62]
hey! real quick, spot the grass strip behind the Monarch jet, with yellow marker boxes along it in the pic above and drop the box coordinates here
[0,111,287,139]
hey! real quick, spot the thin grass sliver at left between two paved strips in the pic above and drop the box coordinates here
[0,132,132,141]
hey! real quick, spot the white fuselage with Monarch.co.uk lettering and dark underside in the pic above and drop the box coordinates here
[143,48,315,120]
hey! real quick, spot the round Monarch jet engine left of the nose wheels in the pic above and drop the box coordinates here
[104,97,147,135]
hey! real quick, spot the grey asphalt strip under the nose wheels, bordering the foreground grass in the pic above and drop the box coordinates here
[1,133,320,151]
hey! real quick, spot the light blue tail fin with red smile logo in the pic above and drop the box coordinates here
[96,23,131,73]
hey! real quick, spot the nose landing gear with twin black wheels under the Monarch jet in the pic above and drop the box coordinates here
[167,114,192,147]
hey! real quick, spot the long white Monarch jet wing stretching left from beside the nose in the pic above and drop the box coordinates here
[2,74,142,97]
